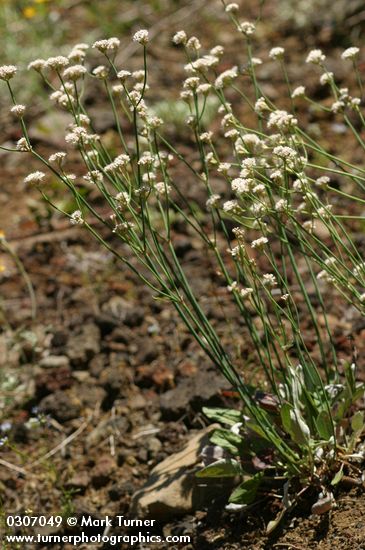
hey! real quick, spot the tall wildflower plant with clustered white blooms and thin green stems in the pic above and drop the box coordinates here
[0,3,365,530]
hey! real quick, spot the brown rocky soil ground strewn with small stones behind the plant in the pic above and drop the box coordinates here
[0,0,365,550]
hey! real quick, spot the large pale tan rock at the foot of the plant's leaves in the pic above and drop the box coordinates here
[130,425,222,520]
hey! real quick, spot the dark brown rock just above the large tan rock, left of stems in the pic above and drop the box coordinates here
[160,371,227,420]
